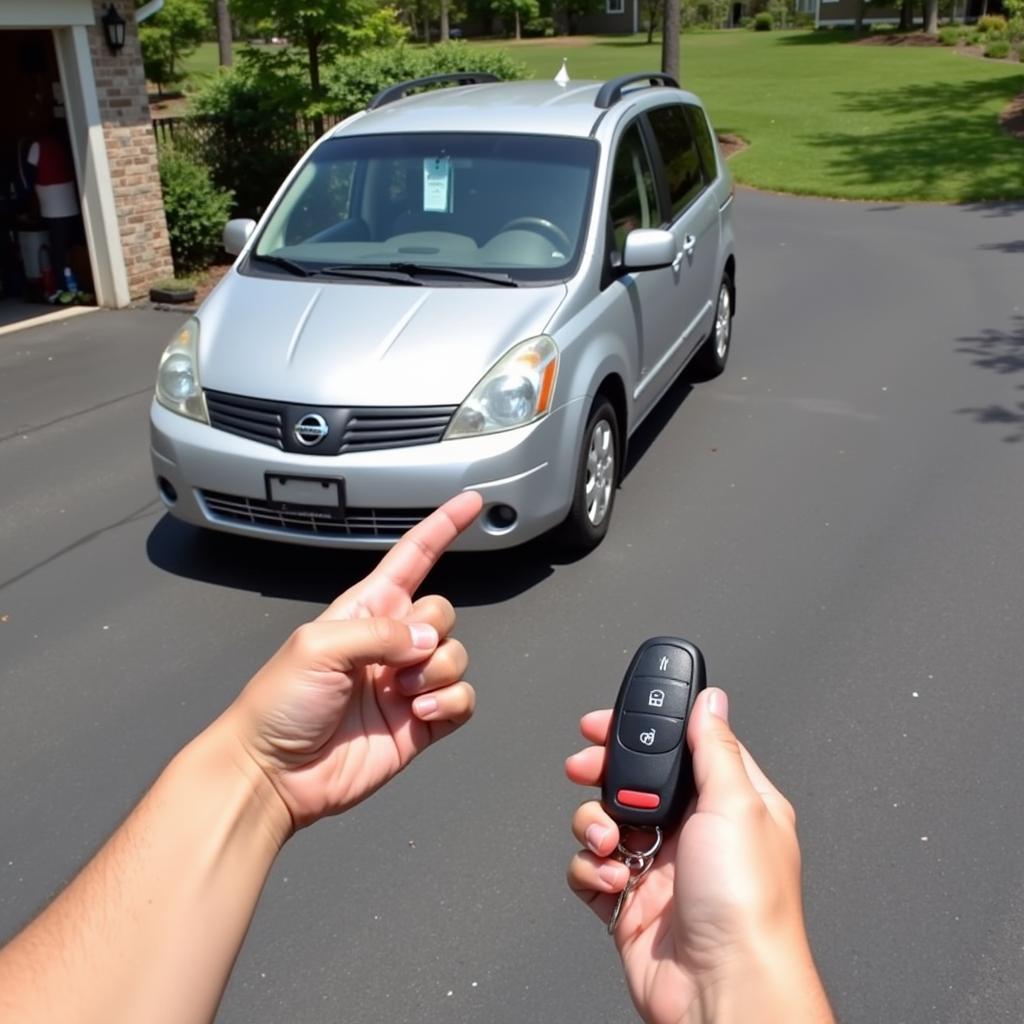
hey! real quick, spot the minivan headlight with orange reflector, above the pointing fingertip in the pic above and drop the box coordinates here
[444,335,558,438]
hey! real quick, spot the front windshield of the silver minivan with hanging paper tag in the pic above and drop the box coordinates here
[253,132,598,286]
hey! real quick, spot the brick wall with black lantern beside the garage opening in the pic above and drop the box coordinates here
[88,0,173,297]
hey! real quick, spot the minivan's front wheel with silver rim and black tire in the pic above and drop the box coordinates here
[560,395,621,551]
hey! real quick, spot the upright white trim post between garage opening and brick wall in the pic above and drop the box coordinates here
[53,25,131,306]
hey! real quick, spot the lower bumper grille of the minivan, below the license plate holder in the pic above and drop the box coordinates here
[200,490,432,540]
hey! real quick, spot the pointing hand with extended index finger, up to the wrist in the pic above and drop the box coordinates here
[223,492,481,830]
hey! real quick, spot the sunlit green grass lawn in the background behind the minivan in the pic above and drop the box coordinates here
[178,31,1024,202]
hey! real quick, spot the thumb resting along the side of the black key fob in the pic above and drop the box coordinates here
[687,687,757,814]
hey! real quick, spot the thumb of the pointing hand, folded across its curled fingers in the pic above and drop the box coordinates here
[292,617,438,672]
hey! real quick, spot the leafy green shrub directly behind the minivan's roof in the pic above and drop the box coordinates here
[326,42,528,117]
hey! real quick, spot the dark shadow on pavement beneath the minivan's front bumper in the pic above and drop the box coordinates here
[145,515,580,607]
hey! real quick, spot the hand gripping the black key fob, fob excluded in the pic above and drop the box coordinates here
[565,689,833,1024]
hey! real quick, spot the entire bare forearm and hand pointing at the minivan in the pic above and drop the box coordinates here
[0,494,480,1024]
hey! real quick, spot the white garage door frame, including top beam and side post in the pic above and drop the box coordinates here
[0,0,131,306]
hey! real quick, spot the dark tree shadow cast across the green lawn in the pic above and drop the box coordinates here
[807,75,1024,200]
